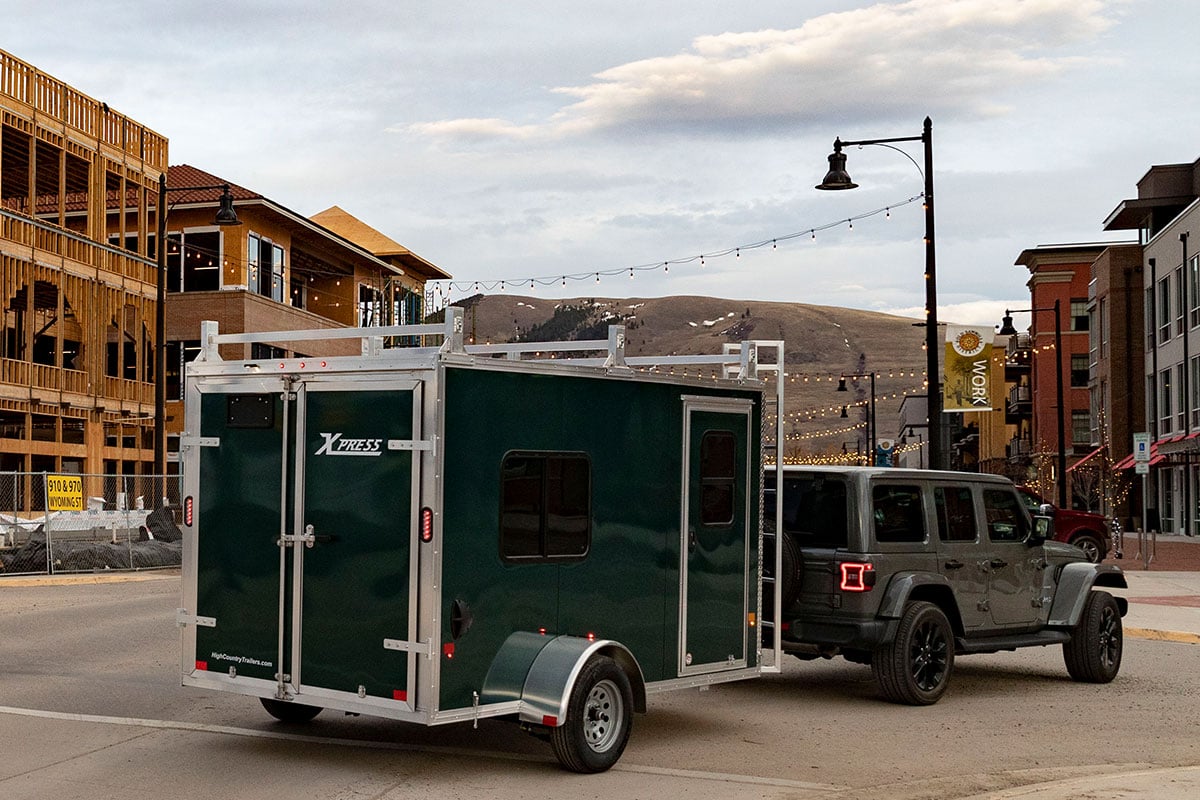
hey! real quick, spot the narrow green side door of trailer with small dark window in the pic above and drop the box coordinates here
[679,397,754,675]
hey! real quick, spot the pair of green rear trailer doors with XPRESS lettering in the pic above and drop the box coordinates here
[194,380,426,715]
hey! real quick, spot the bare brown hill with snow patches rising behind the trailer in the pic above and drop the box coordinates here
[455,294,925,453]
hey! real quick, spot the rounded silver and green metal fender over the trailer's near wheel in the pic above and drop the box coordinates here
[480,631,646,727]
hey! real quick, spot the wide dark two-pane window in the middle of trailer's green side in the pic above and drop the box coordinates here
[500,453,592,563]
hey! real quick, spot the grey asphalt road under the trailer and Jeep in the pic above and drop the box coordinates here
[0,577,1200,800]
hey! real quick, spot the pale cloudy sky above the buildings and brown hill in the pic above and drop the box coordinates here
[7,0,1200,324]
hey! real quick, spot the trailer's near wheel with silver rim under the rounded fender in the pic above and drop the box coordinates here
[550,656,634,772]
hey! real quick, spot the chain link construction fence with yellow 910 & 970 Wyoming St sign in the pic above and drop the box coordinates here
[0,473,182,575]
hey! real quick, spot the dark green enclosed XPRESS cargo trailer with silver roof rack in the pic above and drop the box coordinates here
[179,308,784,772]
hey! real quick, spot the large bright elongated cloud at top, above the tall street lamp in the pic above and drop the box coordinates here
[405,0,1112,140]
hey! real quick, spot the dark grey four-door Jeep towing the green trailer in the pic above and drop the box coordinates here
[763,467,1128,705]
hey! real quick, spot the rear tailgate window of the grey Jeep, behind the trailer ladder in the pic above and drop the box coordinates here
[763,471,848,548]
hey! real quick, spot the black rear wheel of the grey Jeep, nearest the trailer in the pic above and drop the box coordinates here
[871,601,954,705]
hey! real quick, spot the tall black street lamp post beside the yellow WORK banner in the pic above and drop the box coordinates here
[816,116,942,469]
